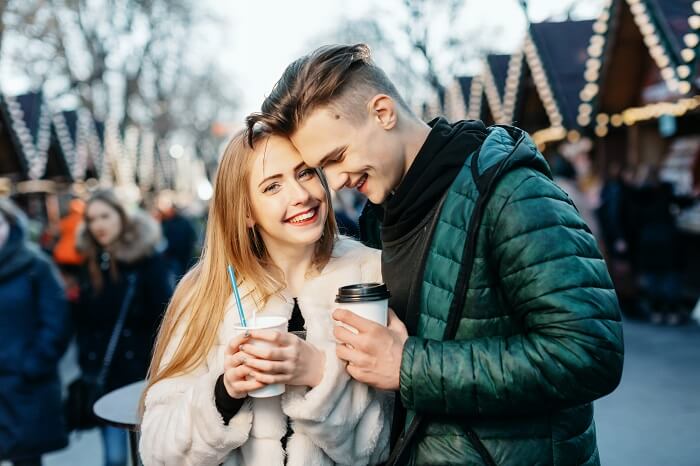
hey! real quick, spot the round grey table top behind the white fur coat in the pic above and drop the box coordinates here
[92,380,146,429]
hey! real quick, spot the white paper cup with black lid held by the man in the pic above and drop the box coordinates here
[335,283,390,333]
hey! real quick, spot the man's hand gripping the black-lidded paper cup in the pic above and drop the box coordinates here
[333,309,408,390]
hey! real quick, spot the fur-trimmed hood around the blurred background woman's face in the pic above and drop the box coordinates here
[76,210,162,264]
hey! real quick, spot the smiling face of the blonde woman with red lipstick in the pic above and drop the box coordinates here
[248,136,328,249]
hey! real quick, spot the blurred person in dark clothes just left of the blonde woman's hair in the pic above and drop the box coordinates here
[155,191,197,280]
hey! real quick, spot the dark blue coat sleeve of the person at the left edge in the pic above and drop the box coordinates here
[22,256,70,378]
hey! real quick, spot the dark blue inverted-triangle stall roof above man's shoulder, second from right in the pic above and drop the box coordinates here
[530,20,593,128]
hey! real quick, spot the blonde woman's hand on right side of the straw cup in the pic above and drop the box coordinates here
[241,330,326,388]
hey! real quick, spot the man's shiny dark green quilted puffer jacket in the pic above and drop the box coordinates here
[392,127,623,466]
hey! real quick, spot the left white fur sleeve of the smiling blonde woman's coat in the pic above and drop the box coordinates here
[139,328,253,466]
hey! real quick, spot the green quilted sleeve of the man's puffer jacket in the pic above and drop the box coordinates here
[400,169,623,416]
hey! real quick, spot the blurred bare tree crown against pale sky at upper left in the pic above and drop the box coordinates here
[0,0,237,164]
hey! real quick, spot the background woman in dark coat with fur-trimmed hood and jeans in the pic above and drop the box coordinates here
[75,191,174,466]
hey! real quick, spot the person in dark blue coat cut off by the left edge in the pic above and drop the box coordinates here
[0,199,70,466]
